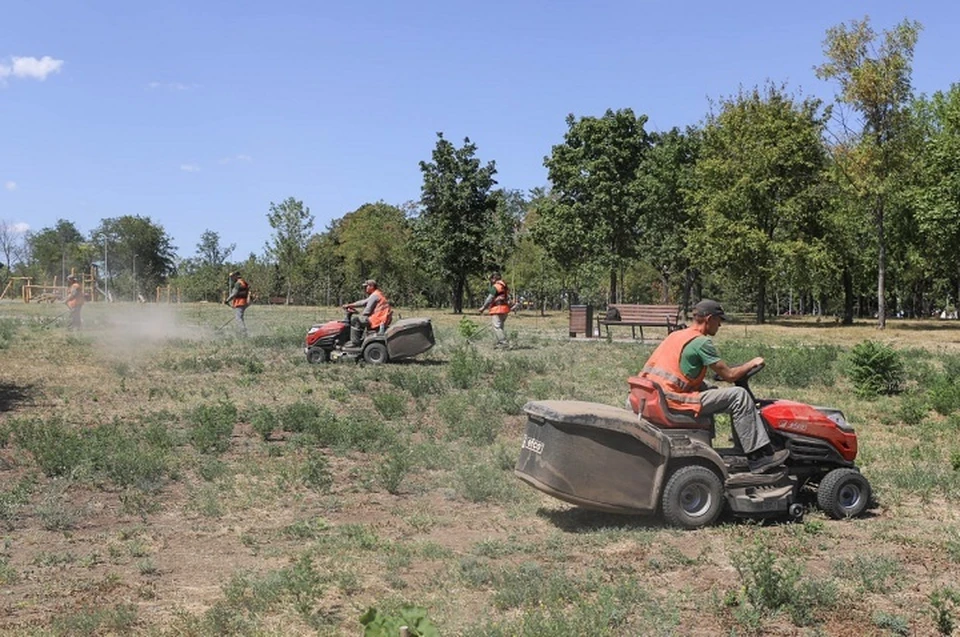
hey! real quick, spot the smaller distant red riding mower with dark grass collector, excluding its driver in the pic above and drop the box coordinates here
[303,309,435,365]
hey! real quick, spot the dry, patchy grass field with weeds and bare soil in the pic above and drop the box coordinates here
[0,303,960,637]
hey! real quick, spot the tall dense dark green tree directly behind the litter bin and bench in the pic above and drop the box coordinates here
[537,108,650,303]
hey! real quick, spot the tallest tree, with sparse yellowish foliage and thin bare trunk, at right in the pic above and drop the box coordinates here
[816,17,922,329]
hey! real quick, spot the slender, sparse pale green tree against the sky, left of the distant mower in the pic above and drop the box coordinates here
[266,197,313,304]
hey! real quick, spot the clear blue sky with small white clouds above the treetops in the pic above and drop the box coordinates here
[0,0,960,258]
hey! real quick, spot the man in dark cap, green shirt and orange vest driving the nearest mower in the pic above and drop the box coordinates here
[640,299,790,473]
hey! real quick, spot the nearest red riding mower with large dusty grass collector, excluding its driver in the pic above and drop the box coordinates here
[515,365,871,529]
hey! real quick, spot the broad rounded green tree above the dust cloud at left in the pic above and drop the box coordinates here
[89,215,177,299]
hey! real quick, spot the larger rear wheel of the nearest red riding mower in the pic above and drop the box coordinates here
[661,465,723,529]
